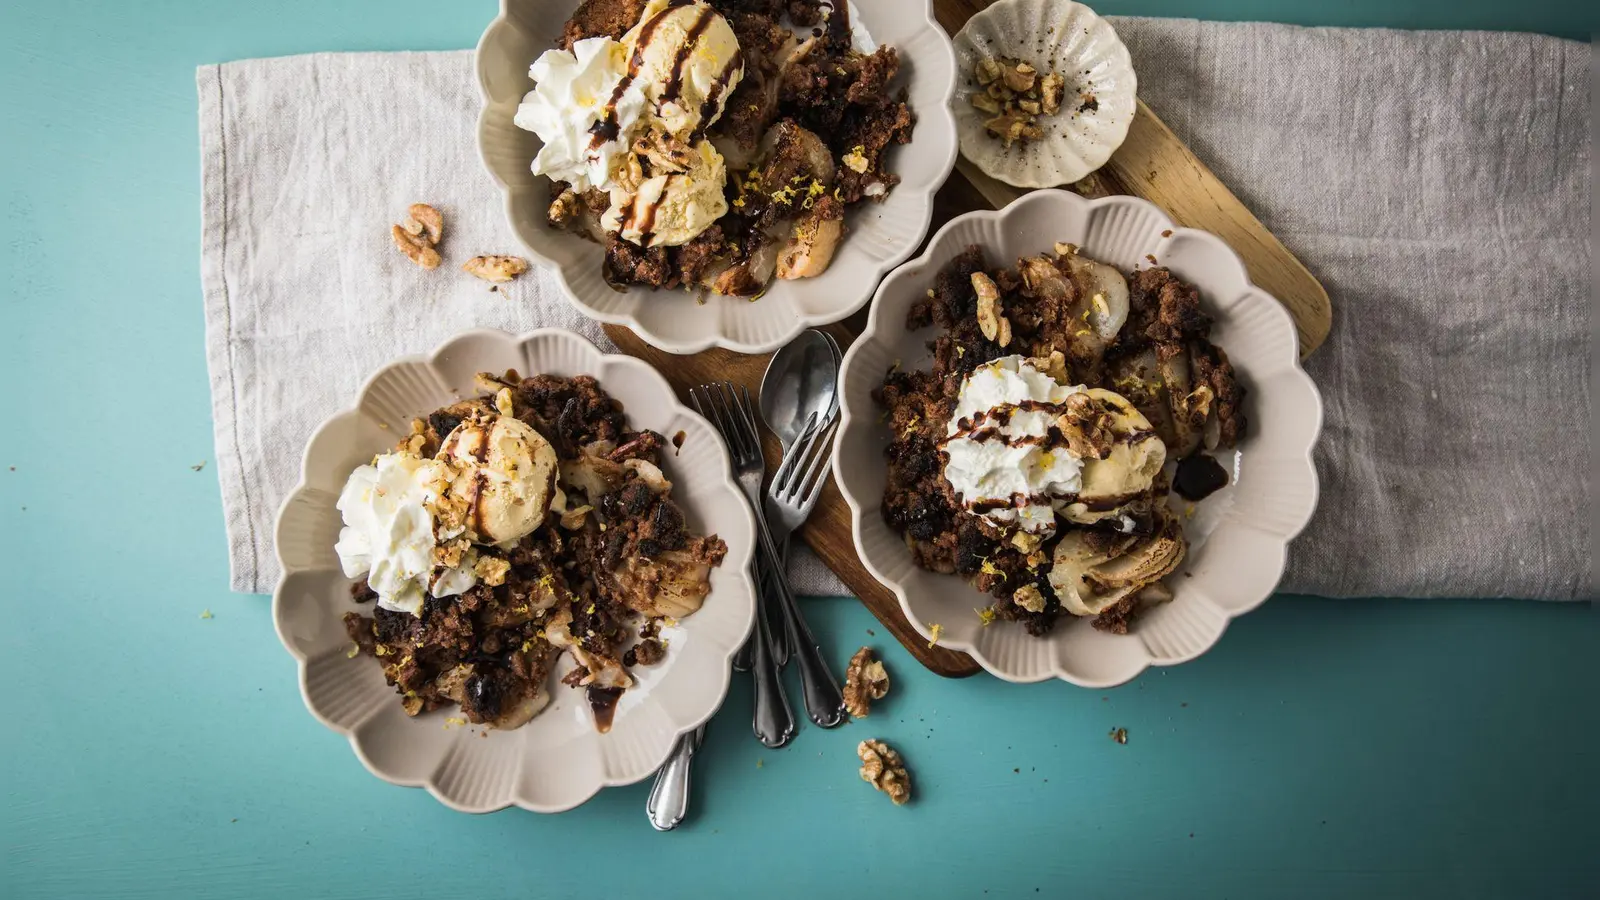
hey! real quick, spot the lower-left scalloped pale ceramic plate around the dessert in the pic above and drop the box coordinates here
[272,328,755,812]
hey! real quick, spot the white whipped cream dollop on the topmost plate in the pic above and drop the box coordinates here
[515,37,650,191]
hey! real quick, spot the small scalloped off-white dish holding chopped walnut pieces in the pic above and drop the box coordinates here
[954,0,1139,187]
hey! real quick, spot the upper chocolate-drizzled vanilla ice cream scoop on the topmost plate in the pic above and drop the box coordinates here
[622,0,744,138]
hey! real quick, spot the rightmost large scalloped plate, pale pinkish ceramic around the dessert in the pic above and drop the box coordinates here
[834,191,1322,687]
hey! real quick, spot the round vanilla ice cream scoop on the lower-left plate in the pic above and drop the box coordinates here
[438,416,558,546]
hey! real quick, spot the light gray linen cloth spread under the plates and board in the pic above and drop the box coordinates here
[197,19,1592,599]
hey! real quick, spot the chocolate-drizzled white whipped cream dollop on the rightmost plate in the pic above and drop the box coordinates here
[942,356,1083,535]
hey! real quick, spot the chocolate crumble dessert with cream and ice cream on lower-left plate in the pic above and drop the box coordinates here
[344,372,726,732]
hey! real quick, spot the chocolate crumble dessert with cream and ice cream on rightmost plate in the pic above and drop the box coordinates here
[875,243,1246,636]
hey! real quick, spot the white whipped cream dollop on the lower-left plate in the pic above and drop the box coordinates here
[333,453,477,615]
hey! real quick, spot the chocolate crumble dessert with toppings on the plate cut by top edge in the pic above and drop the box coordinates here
[515,0,912,298]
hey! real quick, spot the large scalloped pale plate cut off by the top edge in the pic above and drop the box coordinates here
[477,0,957,354]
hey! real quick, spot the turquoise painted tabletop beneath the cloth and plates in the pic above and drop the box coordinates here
[0,0,1600,898]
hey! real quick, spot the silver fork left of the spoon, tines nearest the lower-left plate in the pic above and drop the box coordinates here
[690,381,810,748]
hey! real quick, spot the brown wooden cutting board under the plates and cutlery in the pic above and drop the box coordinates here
[605,0,1333,677]
